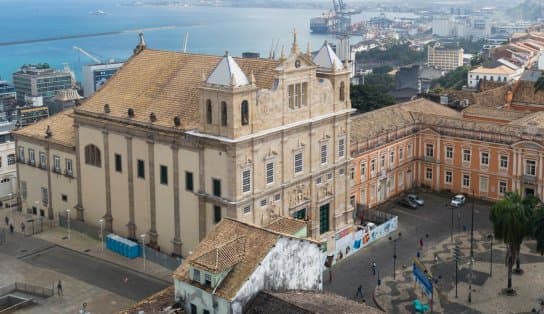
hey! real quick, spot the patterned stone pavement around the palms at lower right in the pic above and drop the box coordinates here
[374,232,544,313]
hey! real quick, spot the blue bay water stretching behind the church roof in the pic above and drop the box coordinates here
[0,0,412,80]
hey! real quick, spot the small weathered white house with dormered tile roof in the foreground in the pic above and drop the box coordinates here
[174,218,324,314]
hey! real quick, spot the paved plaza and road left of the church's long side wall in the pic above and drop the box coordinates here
[0,209,172,313]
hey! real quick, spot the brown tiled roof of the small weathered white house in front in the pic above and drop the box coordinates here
[174,218,318,300]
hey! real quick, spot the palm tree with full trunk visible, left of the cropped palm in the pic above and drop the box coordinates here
[489,192,528,294]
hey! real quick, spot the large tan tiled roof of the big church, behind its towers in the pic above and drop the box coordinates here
[77,49,279,130]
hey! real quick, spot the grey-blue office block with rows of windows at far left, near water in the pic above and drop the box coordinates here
[13,63,74,104]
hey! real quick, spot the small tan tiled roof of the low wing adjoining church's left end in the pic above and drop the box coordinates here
[13,110,76,147]
